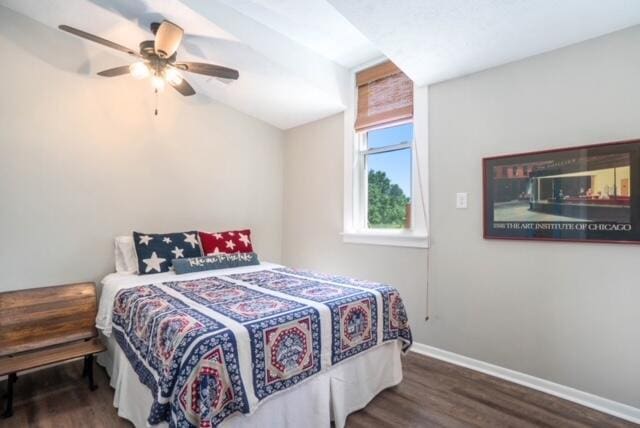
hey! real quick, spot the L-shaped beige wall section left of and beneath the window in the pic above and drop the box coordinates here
[282,114,427,341]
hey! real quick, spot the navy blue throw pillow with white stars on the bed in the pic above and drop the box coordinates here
[133,231,202,275]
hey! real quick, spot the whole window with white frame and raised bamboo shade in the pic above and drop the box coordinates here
[343,61,428,247]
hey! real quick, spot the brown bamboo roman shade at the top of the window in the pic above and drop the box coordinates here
[355,61,413,131]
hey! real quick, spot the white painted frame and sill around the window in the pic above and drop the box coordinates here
[342,58,429,248]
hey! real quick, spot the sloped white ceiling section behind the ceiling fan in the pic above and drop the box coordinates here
[0,0,372,129]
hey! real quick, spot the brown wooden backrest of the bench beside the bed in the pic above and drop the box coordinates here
[0,282,97,357]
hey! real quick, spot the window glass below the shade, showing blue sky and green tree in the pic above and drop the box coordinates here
[360,123,413,229]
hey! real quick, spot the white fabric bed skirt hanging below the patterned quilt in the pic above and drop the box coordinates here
[98,337,402,428]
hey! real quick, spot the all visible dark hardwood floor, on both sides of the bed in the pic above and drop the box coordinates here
[0,353,636,428]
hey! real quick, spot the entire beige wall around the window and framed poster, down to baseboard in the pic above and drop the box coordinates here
[283,28,640,407]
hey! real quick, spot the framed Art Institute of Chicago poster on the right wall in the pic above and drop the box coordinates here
[482,140,640,243]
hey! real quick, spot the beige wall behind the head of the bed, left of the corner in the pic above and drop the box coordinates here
[0,7,284,290]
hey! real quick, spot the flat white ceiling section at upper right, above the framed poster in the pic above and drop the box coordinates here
[328,0,640,86]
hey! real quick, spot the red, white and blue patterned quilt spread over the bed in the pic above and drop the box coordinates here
[113,268,411,428]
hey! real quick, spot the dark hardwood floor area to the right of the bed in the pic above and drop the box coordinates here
[347,352,637,428]
